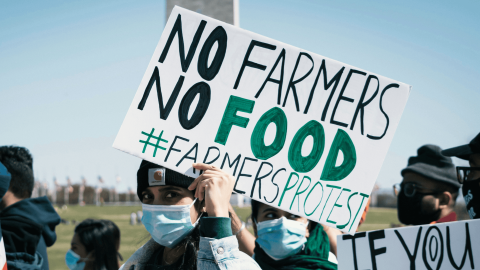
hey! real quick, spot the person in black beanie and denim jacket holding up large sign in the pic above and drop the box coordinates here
[120,160,260,270]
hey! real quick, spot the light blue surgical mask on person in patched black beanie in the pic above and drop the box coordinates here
[142,199,200,248]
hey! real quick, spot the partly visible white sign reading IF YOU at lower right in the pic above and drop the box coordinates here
[337,220,480,270]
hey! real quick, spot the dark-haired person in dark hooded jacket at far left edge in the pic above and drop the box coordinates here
[0,146,60,270]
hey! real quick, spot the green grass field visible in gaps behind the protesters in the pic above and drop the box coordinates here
[48,206,400,270]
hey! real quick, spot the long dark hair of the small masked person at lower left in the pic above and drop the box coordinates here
[75,219,120,270]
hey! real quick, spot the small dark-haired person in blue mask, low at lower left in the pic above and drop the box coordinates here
[65,219,122,270]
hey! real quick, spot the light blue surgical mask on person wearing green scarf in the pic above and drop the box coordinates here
[256,217,308,261]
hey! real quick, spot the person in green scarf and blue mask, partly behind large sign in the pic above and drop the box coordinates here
[252,200,337,270]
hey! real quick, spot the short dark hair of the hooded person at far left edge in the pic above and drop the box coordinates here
[0,146,34,199]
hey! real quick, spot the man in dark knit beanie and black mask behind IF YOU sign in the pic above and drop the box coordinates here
[394,144,460,225]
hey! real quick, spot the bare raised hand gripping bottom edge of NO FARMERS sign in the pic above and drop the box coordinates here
[188,163,235,217]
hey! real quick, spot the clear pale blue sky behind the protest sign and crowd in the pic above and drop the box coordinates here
[0,0,480,190]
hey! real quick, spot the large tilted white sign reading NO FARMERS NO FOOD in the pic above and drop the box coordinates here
[113,7,410,232]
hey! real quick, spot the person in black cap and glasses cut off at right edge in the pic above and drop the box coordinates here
[442,133,480,219]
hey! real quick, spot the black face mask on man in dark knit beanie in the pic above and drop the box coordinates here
[397,191,441,225]
